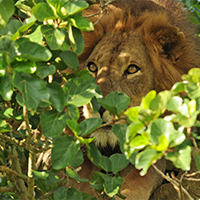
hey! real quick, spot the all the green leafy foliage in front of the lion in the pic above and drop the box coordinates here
[0,0,200,200]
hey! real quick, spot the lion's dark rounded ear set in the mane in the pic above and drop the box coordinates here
[151,26,186,62]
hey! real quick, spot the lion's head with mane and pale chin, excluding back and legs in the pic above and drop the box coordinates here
[79,1,199,153]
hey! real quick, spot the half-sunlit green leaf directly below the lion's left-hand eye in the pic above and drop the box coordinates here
[63,77,98,107]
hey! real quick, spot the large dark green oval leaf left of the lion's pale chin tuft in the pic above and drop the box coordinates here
[51,135,80,170]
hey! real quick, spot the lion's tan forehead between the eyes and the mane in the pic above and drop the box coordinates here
[89,33,149,71]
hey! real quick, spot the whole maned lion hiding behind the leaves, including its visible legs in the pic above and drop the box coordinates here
[68,0,200,200]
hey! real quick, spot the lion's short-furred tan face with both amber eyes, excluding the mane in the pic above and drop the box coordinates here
[85,31,155,106]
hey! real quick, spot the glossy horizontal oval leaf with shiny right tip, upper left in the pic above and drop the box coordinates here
[17,38,52,61]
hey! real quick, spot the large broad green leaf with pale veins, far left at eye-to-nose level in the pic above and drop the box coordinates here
[12,72,49,110]
